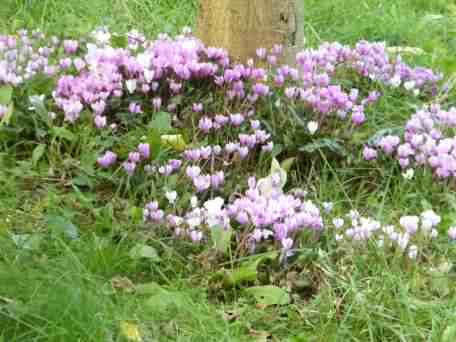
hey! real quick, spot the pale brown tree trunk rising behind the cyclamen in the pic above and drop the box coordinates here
[197,0,304,64]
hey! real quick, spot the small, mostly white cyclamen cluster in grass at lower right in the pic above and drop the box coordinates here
[332,210,442,259]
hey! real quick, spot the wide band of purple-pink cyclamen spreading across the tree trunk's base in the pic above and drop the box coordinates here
[49,26,441,128]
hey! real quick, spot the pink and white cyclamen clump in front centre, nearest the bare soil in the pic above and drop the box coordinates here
[144,177,323,252]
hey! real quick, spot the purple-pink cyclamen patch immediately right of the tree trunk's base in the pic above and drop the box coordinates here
[282,41,442,125]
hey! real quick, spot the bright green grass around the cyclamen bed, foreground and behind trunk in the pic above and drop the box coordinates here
[0,0,456,342]
